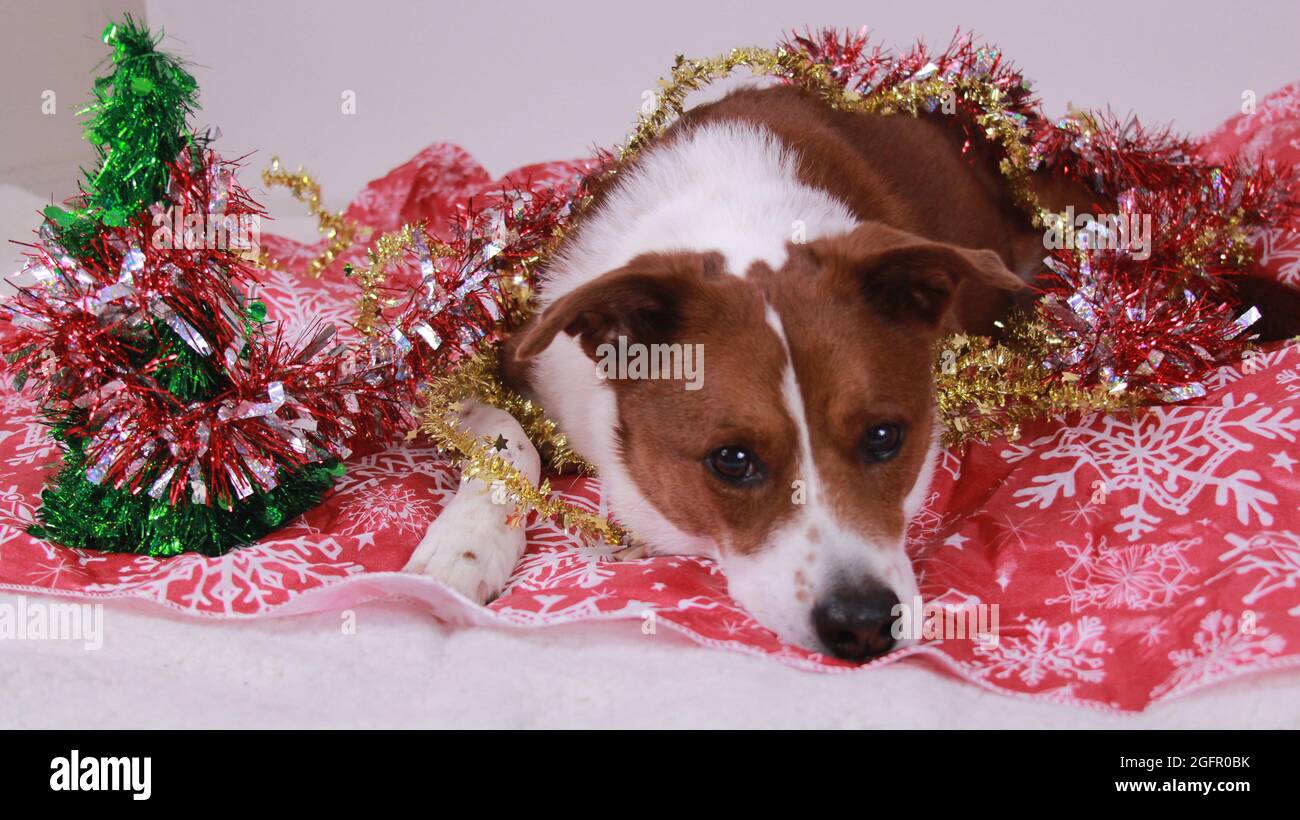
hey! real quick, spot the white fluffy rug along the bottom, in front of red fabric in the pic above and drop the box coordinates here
[0,595,1300,728]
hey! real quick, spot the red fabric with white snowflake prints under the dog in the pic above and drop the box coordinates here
[0,84,1300,710]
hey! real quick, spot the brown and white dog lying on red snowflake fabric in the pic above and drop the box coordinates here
[408,87,1289,660]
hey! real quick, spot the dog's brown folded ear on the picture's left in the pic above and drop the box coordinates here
[512,253,722,361]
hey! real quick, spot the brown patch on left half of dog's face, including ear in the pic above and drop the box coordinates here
[516,253,797,554]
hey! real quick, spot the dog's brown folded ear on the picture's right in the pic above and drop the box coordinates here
[810,222,1026,325]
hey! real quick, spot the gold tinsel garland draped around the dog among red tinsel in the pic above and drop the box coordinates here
[268,48,1248,543]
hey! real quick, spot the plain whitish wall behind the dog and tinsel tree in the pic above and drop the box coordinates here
[0,0,1300,224]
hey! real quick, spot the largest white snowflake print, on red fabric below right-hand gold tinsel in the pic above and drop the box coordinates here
[1002,392,1300,541]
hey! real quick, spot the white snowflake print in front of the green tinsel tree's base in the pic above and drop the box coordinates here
[86,533,364,615]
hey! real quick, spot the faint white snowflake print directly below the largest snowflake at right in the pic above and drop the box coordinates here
[1043,533,1201,612]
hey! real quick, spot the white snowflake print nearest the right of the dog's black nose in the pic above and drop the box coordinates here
[967,615,1108,686]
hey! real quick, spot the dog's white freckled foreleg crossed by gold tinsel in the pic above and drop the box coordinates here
[404,403,542,603]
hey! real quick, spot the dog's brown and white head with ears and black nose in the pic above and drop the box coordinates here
[515,224,1022,660]
